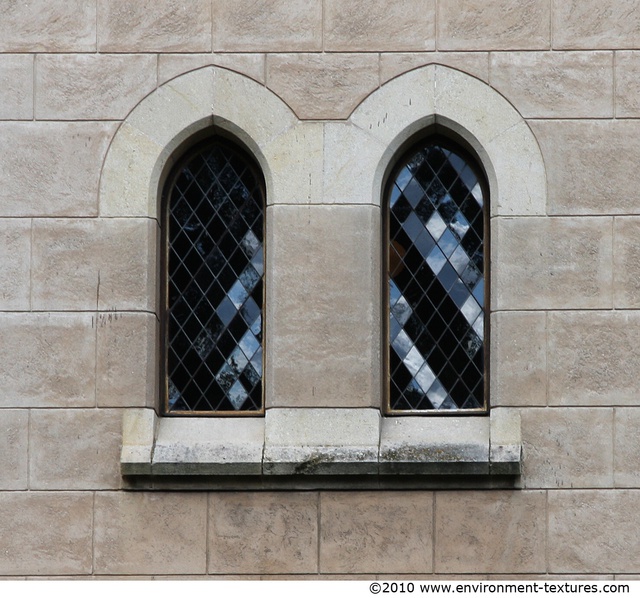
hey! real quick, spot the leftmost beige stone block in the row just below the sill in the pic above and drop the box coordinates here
[0,492,93,575]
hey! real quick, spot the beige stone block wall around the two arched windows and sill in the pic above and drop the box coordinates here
[0,0,640,579]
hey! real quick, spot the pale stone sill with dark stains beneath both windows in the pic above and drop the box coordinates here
[121,408,522,487]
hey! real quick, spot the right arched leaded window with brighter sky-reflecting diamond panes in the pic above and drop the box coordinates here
[386,136,488,413]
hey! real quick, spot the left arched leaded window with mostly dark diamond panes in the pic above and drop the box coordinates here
[162,137,265,415]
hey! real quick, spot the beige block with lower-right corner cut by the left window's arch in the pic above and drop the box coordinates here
[35,54,157,120]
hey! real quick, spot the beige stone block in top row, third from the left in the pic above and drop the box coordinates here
[213,0,322,52]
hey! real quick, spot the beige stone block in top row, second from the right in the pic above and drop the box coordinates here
[437,0,551,51]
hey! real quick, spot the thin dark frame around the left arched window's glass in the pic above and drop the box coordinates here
[159,136,267,417]
